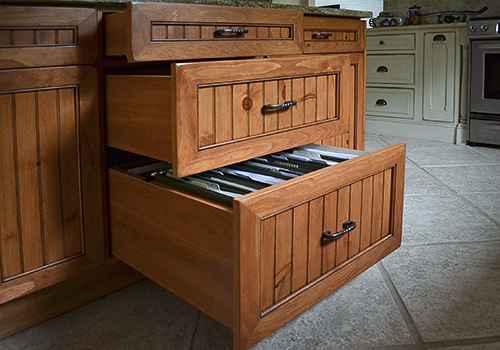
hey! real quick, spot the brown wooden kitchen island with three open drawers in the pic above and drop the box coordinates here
[0,0,405,349]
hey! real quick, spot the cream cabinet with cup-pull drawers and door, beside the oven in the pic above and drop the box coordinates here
[366,23,468,143]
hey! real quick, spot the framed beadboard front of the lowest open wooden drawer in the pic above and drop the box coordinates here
[234,144,405,349]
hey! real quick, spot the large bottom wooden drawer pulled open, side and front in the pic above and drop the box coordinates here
[109,144,405,349]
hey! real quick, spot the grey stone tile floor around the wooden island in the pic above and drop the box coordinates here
[0,135,500,350]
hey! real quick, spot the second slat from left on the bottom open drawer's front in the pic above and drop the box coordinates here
[274,209,293,301]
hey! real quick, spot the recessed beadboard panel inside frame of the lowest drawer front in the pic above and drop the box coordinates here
[260,168,394,316]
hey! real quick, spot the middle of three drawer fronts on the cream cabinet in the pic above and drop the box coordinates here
[366,55,415,84]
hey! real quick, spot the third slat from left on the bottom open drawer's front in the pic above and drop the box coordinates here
[292,203,309,292]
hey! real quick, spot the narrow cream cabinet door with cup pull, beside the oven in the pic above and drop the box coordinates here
[423,33,455,122]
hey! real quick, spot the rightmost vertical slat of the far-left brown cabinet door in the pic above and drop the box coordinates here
[59,88,81,256]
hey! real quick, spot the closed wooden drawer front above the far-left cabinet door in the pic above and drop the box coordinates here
[0,6,97,69]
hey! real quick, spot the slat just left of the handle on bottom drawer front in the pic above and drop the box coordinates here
[307,197,323,282]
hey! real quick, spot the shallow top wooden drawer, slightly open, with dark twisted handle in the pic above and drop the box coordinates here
[105,3,303,62]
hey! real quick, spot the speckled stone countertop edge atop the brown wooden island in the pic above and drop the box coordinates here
[0,0,372,18]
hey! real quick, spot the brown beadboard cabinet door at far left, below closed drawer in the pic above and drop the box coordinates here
[0,67,104,304]
